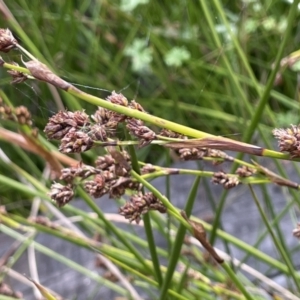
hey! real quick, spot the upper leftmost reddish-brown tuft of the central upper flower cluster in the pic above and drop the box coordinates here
[44,111,90,140]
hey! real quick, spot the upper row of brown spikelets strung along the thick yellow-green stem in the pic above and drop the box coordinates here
[44,92,238,164]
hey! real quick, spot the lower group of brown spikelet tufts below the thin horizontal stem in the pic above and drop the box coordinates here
[49,150,166,223]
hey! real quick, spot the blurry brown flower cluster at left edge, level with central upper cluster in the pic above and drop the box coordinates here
[0,99,32,126]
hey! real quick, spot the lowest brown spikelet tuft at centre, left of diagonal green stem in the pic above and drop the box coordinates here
[119,192,167,224]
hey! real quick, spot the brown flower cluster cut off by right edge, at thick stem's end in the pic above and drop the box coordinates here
[273,125,300,158]
